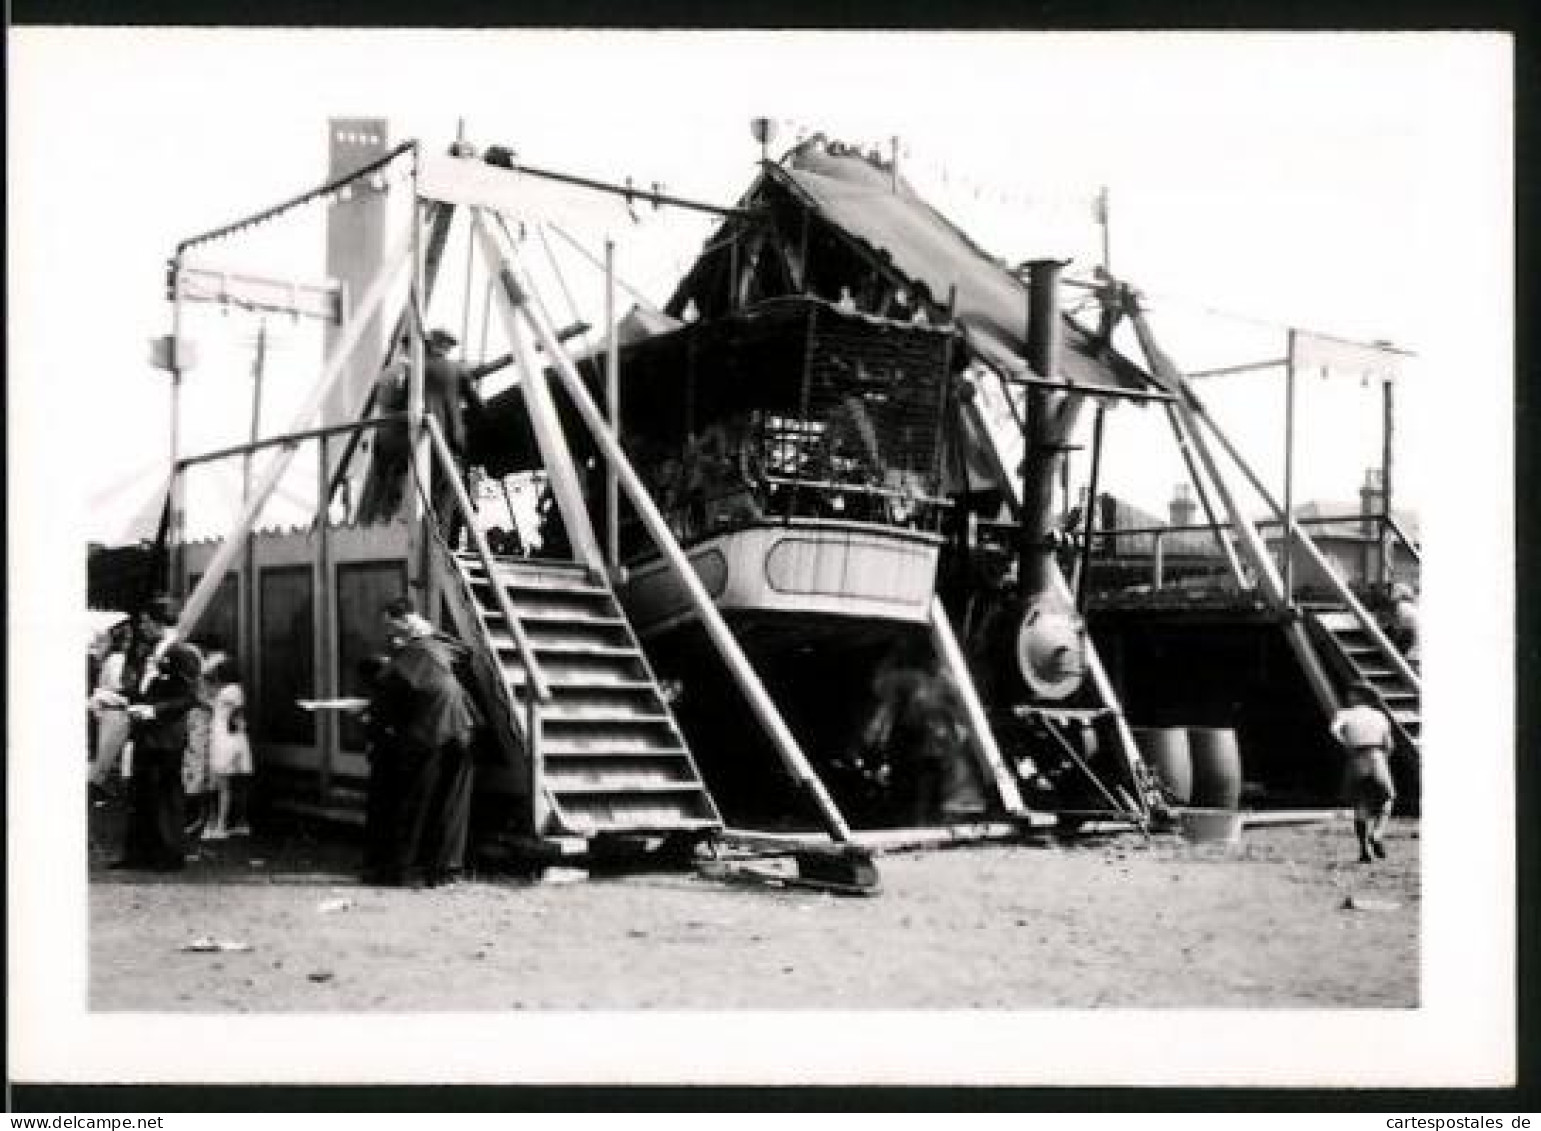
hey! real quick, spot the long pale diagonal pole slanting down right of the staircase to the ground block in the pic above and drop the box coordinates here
[486,217,851,843]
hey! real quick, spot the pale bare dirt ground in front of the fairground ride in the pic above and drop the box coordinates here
[89,809,1419,1012]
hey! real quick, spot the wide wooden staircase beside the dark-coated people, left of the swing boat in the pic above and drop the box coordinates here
[455,553,723,838]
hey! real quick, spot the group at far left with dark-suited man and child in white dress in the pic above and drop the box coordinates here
[89,599,253,871]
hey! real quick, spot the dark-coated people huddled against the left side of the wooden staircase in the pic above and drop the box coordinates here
[361,598,485,888]
